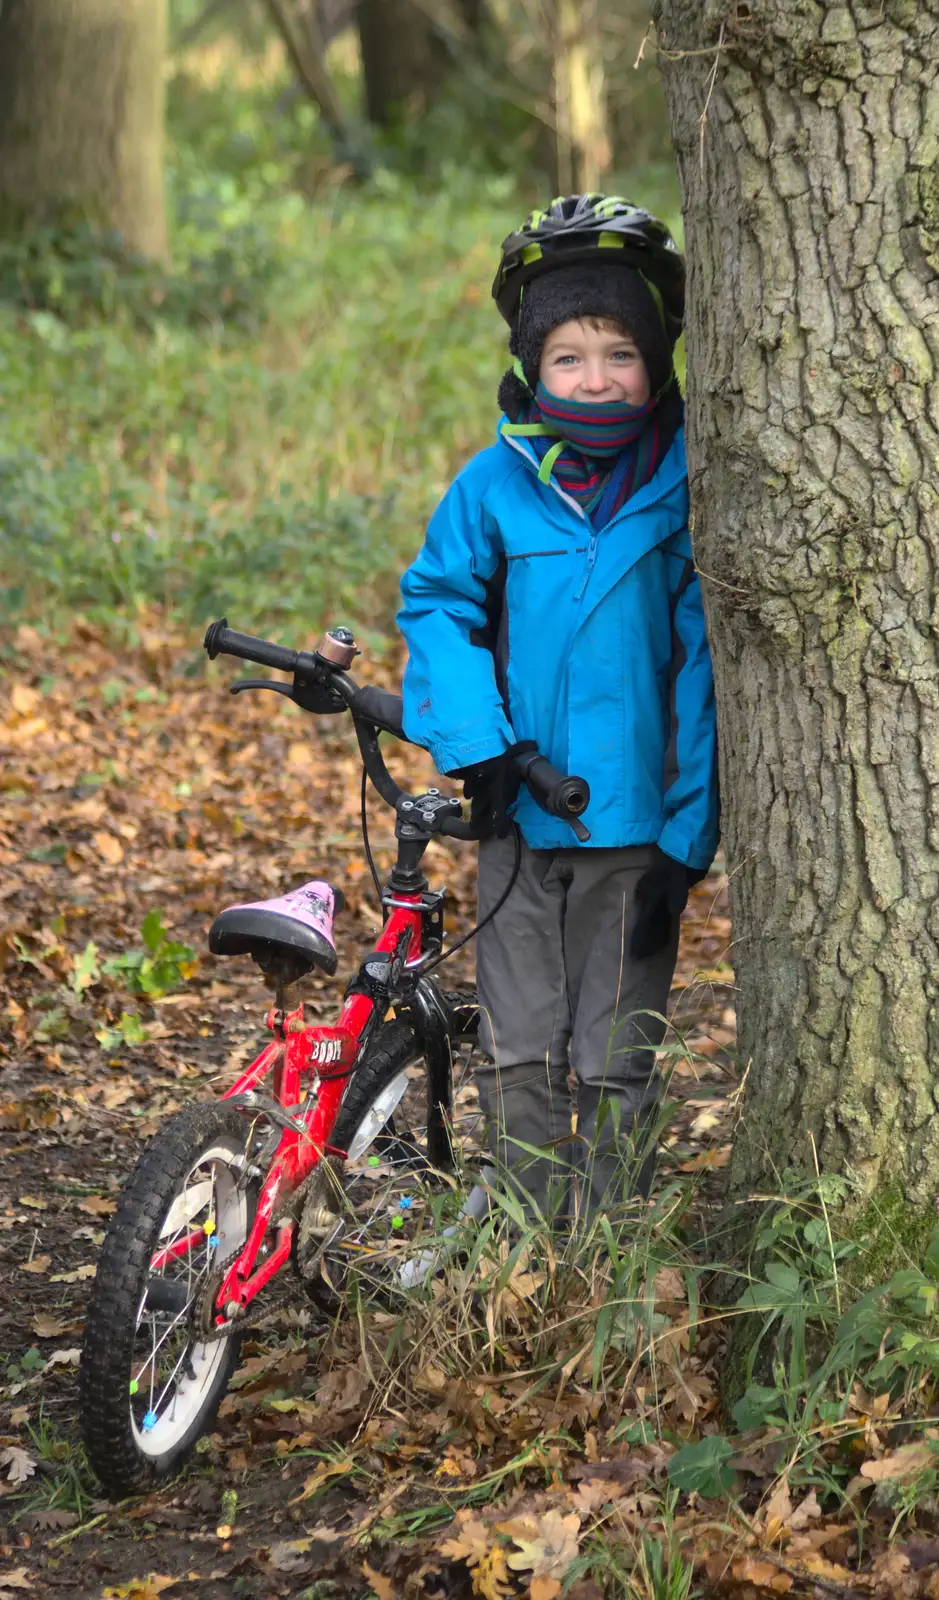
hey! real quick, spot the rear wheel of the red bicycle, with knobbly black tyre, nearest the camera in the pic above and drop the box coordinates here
[78,1106,254,1494]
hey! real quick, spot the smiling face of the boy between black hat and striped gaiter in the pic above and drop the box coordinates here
[537,320,651,405]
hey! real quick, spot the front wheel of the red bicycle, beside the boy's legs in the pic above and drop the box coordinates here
[299,990,481,1312]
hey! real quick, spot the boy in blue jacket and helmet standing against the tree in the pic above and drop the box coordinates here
[398,195,718,1216]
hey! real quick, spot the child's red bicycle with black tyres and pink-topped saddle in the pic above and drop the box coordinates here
[78,618,589,1494]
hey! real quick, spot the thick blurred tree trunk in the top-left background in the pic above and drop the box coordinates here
[0,0,166,258]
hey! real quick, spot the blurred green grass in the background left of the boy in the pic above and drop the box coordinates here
[0,50,678,637]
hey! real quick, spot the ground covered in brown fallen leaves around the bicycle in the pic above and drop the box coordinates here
[0,626,939,1600]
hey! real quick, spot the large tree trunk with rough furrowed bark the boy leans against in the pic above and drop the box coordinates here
[656,0,939,1229]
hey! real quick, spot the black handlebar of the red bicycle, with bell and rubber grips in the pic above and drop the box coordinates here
[205,618,590,842]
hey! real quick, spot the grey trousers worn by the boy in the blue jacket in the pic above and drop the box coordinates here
[477,838,678,1216]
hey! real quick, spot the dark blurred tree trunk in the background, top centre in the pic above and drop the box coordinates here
[357,0,450,128]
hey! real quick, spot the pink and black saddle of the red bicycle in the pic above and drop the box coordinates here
[208,878,346,974]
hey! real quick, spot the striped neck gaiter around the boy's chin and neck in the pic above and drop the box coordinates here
[502,379,685,528]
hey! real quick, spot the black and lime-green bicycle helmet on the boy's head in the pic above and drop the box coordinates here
[493,194,685,344]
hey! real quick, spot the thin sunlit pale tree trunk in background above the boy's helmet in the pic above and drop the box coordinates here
[553,0,609,194]
